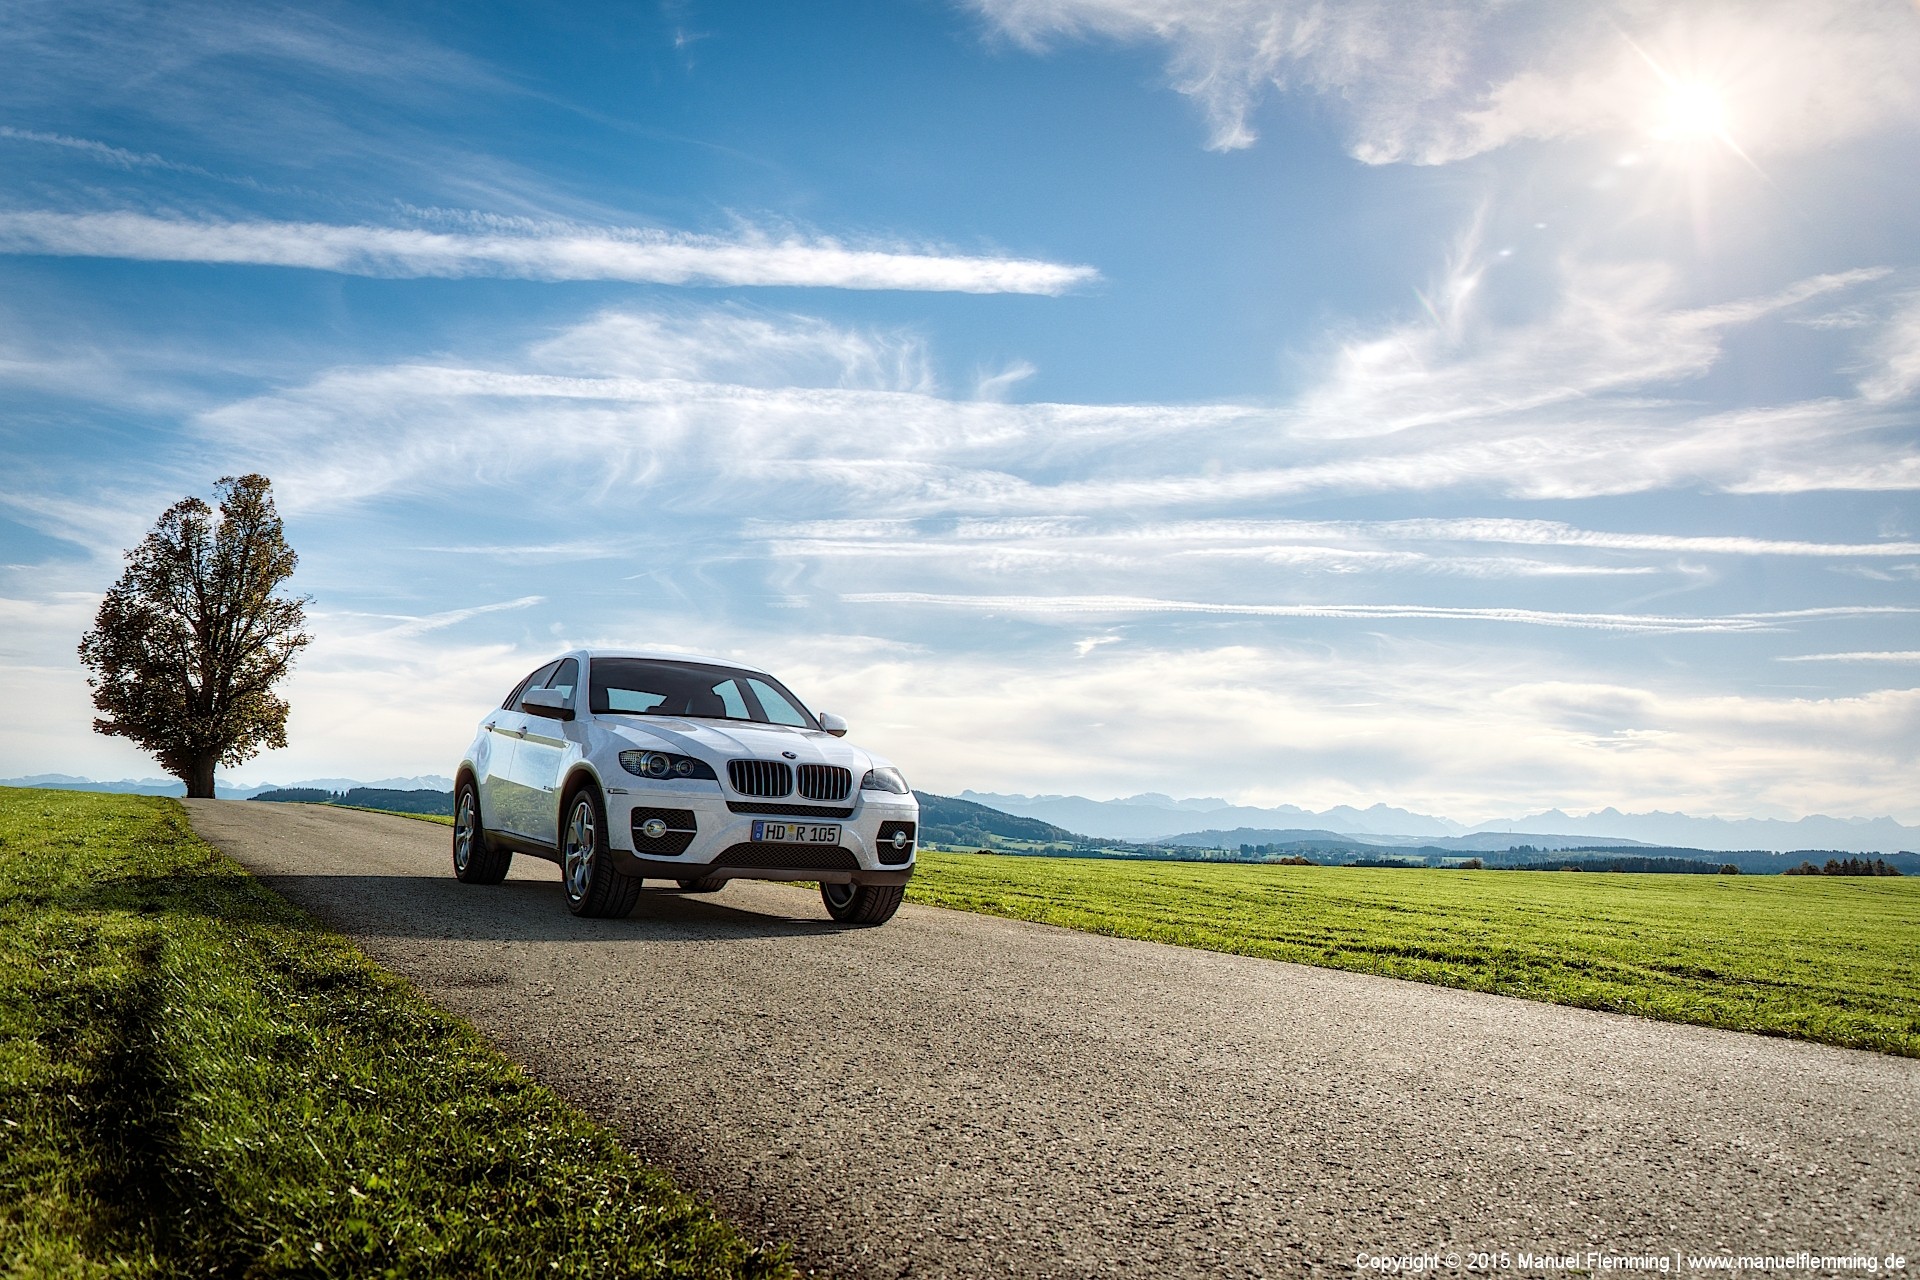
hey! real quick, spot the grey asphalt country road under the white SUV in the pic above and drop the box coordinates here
[188,800,1920,1278]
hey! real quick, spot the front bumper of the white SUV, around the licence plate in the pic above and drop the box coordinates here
[607,783,920,885]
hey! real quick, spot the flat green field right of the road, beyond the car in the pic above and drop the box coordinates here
[906,850,1920,1057]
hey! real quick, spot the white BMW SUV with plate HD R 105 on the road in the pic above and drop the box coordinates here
[453,651,920,925]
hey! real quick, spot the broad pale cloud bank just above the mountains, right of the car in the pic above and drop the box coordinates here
[780,633,1920,821]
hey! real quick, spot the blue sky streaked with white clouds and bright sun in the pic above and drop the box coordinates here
[0,0,1920,821]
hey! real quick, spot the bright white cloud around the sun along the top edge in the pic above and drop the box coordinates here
[972,0,1920,163]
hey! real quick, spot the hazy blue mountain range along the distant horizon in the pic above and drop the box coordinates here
[960,791,1920,854]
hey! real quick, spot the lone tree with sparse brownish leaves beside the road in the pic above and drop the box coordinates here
[81,476,313,796]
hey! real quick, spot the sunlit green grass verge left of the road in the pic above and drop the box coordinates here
[0,789,793,1278]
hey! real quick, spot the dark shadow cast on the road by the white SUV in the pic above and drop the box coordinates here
[247,875,845,942]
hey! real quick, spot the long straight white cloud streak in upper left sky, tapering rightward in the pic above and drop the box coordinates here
[0,211,1098,294]
